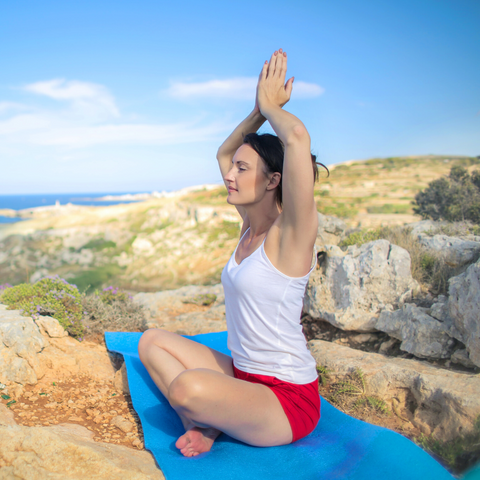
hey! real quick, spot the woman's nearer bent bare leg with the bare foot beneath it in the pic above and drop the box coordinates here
[169,368,292,456]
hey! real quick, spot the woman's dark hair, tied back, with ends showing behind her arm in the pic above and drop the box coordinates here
[243,133,330,206]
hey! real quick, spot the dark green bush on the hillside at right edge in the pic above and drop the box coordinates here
[413,166,480,224]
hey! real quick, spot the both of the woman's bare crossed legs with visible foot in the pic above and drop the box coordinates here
[138,329,292,456]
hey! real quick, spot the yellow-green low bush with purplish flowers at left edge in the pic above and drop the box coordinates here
[0,275,84,337]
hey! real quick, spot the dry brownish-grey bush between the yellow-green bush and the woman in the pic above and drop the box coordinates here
[82,287,146,334]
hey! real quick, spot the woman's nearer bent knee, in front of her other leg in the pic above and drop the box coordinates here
[168,369,205,412]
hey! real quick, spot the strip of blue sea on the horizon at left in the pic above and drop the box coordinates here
[0,192,144,223]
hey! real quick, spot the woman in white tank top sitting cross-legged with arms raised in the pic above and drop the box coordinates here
[138,49,320,456]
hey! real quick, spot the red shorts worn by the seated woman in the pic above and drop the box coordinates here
[233,365,320,442]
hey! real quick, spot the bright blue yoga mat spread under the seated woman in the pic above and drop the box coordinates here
[105,332,454,480]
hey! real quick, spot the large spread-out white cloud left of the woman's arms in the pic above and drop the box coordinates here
[0,79,233,150]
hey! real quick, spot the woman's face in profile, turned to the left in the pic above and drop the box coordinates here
[225,144,270,205]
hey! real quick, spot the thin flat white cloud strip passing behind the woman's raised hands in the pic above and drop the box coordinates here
[167,77,325,100]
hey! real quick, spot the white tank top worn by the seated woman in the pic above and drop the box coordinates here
[222,230,317,385]
